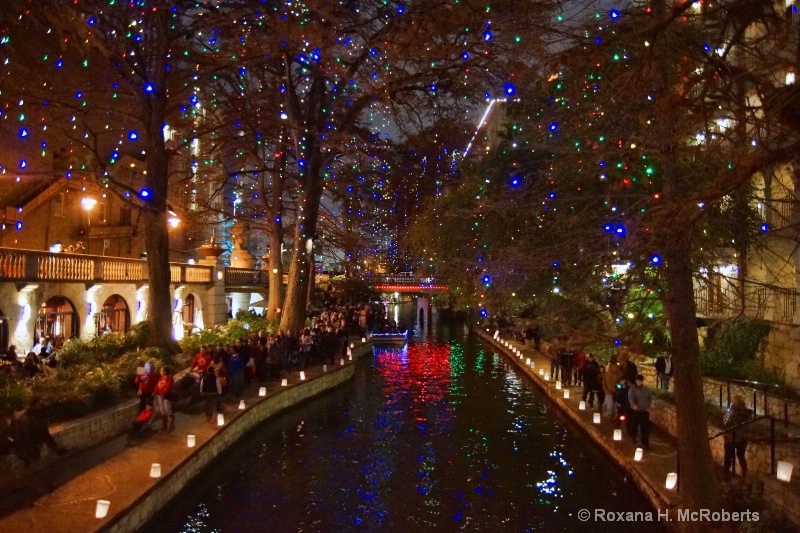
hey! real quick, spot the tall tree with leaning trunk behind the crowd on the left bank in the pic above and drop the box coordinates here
[205,0,553,330]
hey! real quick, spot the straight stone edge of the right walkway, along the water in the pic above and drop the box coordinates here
[472,328,676,527]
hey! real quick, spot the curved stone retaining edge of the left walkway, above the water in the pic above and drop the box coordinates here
[95,343,372,533]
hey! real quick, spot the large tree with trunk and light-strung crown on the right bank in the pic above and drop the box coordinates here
[412,1,800,529]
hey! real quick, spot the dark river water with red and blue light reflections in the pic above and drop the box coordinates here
[150,306,663,533]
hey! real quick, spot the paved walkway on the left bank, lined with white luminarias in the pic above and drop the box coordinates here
[0,343,362,533]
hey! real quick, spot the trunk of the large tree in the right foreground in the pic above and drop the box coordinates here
[651,0,721,520]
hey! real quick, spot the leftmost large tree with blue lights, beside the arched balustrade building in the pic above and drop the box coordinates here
[0,0,231,351]
